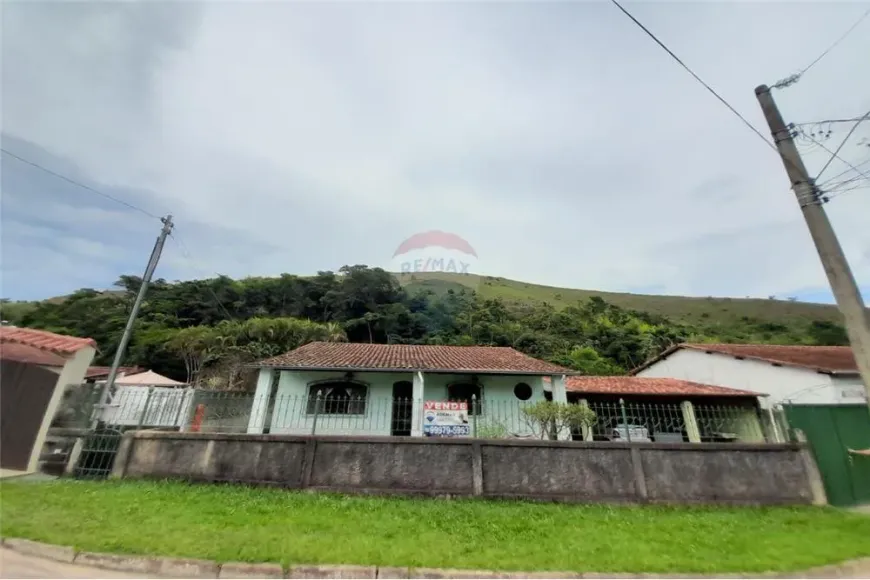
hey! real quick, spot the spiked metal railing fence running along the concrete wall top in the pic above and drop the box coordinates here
[53,385,788,477]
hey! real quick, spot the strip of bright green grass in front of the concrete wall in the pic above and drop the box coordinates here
[0,481,870,573]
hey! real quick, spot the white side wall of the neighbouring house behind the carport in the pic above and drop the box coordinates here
[637,349,841,408]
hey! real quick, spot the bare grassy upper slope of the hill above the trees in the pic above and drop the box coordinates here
[400,273,842,326]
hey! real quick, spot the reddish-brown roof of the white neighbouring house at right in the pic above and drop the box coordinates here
[631,343,858,374]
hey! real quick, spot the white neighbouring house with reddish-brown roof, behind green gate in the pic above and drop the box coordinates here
[632,344,867,408]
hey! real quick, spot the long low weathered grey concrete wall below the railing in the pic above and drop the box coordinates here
[113,431,825,504]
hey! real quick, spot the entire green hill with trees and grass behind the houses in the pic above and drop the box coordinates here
[2,266,848,382]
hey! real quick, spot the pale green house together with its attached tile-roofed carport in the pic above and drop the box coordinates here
[247,342,778,443]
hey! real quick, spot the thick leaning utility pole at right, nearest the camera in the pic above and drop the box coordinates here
[755,85,870,405]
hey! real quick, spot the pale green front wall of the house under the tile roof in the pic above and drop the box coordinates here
[262,369,544,436]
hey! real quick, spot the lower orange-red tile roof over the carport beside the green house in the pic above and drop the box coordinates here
[565,377,766,397]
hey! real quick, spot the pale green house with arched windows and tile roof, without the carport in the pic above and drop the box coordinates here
[247,342,577,436]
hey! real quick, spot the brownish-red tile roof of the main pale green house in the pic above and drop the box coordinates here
[259,342,573,375]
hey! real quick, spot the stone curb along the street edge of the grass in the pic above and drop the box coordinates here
[2,538,870,580]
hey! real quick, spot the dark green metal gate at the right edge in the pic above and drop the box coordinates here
[783,405,870,506]
